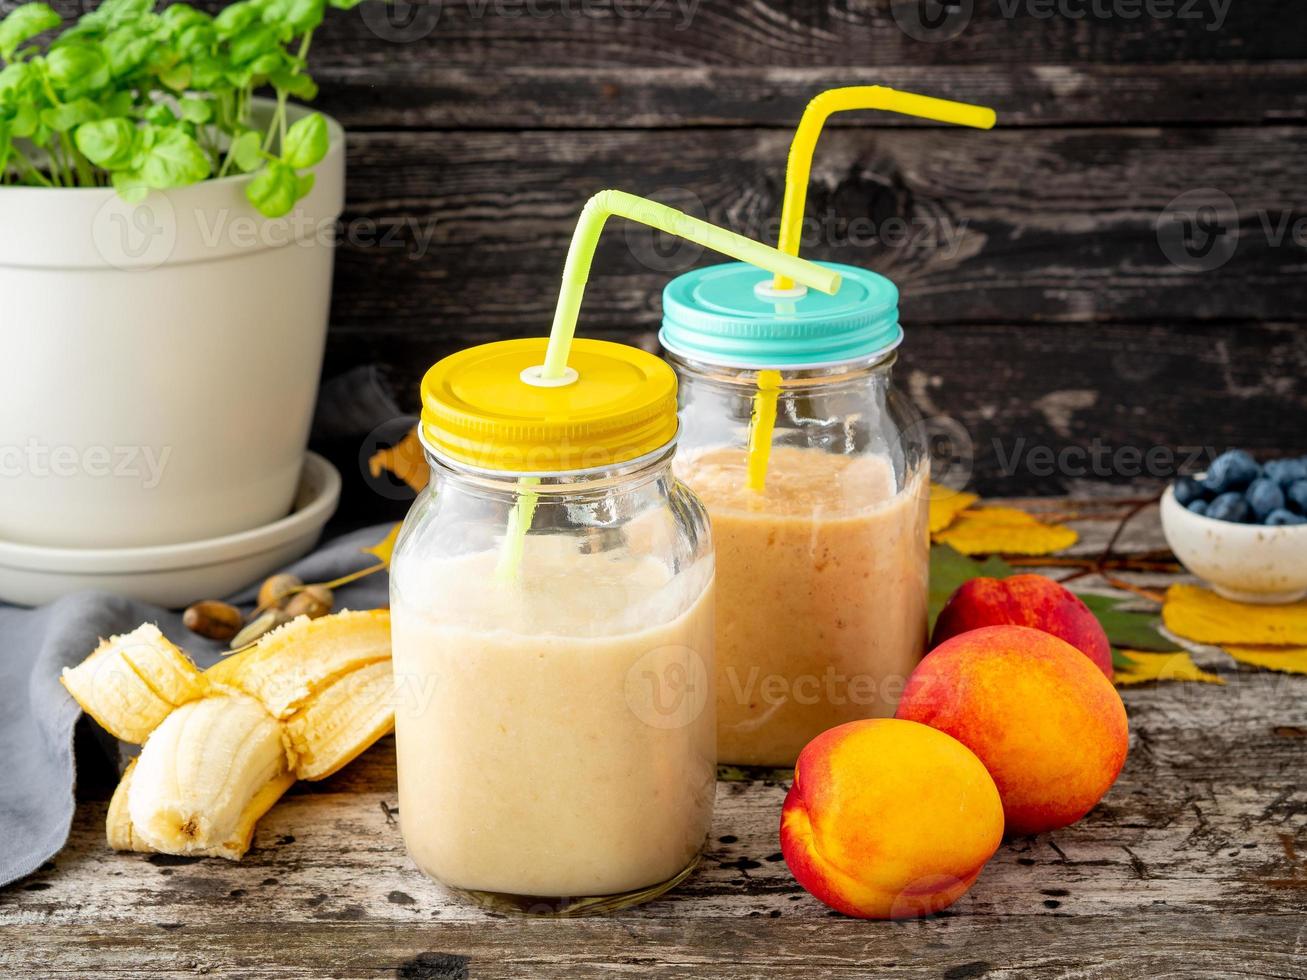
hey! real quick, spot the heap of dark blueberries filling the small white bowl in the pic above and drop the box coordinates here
[1171,449,1307,527]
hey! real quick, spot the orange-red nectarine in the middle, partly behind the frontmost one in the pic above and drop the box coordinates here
[895,626,1129,834]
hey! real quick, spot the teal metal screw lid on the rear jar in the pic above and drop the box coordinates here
[659,263,903,368]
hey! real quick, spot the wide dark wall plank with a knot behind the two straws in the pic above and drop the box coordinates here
[326,127,1307,338]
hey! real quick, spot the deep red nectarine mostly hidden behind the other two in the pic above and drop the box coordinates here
[931,575,1112,681]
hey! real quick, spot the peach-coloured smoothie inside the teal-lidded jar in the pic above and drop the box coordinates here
[678,447,929,766]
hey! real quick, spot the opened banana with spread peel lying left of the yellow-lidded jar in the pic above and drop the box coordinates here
[61,610,395,860]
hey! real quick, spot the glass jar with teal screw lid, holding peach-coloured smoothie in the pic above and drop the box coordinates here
[661,264,929,766]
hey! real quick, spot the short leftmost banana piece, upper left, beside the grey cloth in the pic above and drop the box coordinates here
[60,623,204,745]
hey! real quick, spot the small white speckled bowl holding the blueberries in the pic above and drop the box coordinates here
[1162,474,1307,604]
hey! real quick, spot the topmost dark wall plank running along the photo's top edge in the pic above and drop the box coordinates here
[291,0,1307,74]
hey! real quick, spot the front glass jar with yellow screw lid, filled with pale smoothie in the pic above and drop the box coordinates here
[391,340,716,913]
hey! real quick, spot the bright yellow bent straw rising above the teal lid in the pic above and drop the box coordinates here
[774,85,997,290]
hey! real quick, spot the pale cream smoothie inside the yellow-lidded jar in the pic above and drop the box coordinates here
[391,546,716,898]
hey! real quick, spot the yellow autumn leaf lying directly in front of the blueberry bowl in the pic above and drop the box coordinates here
[1162,585,1307,647]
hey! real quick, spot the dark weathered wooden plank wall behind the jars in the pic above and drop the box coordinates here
[58,0,1307,493]
